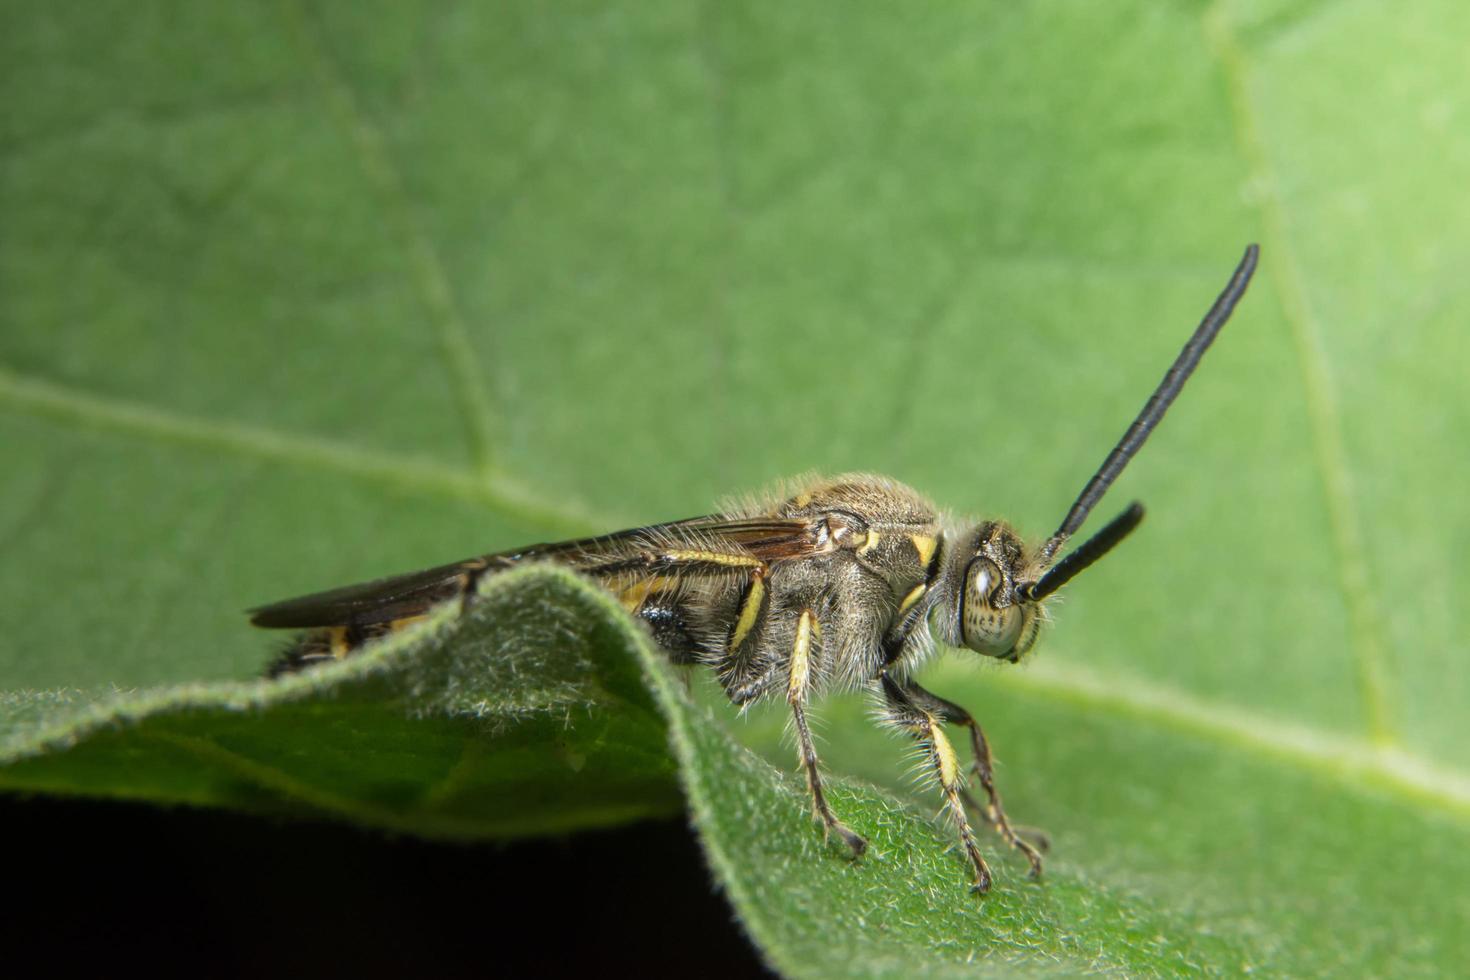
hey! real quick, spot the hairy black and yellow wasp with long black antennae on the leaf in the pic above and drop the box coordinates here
[251,245,1257,892]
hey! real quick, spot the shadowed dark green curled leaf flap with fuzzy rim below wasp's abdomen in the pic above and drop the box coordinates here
[0,569,681,839]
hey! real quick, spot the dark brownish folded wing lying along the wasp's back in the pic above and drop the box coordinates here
[250,514,826,629]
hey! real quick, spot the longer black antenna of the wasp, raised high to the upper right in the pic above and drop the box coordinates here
[1025,245,1260,581]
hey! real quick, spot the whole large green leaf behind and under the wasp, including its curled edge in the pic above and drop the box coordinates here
[0,0,1470,976]
